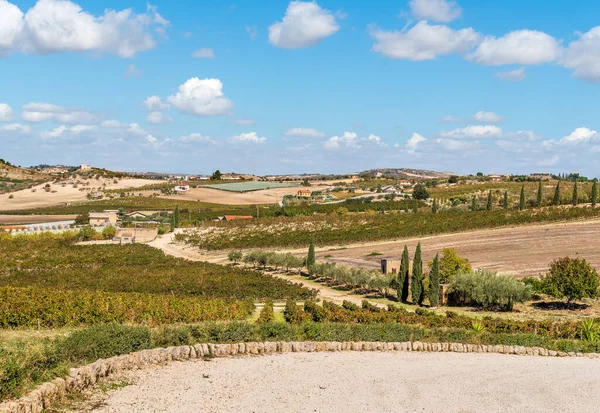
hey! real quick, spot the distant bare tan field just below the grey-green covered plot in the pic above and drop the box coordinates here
[160,183,330,205]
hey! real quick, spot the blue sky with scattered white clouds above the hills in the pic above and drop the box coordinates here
[0,0,600,175]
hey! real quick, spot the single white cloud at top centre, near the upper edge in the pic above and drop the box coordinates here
[269,1,340,49]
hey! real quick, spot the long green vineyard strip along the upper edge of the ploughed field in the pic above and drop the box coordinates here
[178,207,600,250]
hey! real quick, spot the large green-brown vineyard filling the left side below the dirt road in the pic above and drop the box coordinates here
[0,235,314,327]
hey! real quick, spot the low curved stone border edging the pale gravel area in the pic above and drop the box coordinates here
[0,341,600,413]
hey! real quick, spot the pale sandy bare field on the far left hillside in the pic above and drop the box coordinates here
[0,178,160,211]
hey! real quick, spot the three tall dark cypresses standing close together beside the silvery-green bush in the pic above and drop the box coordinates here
[398,243,440,307]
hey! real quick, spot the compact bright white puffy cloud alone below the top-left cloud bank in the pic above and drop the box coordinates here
[167,77,233,116]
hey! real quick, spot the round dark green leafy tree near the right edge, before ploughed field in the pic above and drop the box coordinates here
[542,257,600,303]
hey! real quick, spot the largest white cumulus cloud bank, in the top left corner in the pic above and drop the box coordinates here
[0,0,169,57]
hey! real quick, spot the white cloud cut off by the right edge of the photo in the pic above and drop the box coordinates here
[561,26,600,82]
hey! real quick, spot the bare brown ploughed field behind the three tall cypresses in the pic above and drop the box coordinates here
[317,220,600,277]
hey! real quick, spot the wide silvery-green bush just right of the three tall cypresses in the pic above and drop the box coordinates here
[450,270,532,311]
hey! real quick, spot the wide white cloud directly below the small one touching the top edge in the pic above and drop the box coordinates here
[370,21,480,61]
